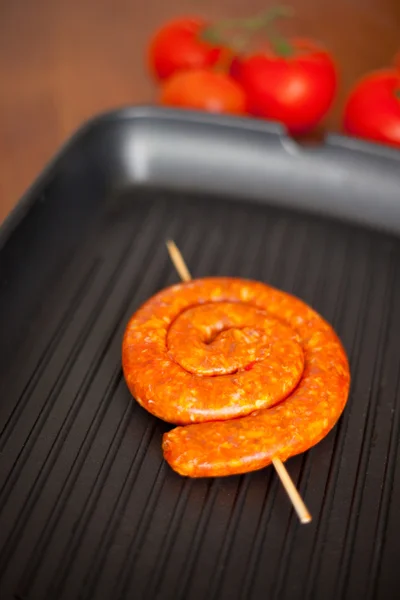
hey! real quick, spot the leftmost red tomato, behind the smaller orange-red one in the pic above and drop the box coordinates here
[149,18,220,79]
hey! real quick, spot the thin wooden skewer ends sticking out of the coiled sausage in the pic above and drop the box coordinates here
[167,240,311,523]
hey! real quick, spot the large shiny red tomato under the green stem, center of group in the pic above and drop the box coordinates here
[232,40,337,134]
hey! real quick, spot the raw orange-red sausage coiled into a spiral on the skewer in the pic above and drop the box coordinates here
[122,278,350,477]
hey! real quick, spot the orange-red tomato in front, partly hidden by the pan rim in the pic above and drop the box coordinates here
[160,69,246,115]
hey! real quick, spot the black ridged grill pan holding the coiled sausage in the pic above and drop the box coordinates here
[0,107,400,600]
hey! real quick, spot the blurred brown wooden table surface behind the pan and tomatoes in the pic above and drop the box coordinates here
[0,0,400,221]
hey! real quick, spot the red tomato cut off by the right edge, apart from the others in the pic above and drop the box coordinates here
[343,69,400,146]
